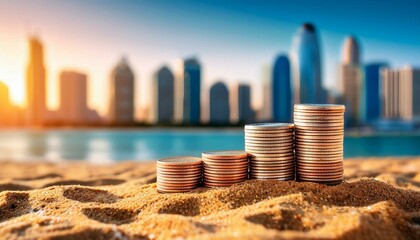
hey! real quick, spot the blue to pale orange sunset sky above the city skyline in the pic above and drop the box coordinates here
[0,0,420,118]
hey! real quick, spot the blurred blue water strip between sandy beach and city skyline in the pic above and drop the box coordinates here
[0,129,420,162]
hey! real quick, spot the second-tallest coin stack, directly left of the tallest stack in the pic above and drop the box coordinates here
[245,123,295,181]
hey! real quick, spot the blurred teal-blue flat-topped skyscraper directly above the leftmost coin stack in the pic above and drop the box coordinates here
[183,58,201,124]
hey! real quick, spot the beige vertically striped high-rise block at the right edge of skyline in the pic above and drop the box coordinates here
[381,67,420,121]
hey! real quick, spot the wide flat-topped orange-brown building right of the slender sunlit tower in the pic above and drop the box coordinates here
[60,71,88,124]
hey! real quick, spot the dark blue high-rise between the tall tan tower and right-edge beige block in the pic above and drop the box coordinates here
[360,63,388,123]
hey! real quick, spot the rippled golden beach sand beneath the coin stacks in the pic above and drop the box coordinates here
[0,158,420,239]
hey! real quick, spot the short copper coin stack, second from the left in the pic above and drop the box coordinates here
[202,151,248,187]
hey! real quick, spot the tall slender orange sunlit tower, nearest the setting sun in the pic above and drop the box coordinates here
[26,37,46,125]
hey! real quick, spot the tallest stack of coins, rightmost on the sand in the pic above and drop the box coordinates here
[294,104,345,185]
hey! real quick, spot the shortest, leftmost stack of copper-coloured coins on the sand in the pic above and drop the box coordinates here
[156,157,202,193]
